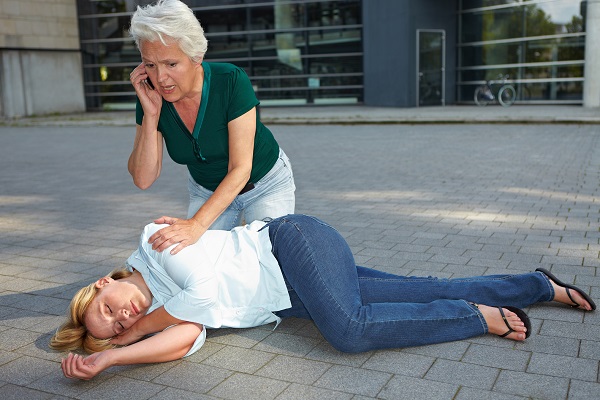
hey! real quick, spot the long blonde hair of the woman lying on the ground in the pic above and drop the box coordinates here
[50,268,132,353]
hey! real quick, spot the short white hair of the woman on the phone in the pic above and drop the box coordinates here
[129,0,208,62]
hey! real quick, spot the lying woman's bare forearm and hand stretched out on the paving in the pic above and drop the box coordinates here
[61,322,204,380]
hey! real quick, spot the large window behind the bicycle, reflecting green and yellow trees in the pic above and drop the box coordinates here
[458,0,585,102]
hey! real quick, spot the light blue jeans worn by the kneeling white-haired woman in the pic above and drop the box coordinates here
[188,149,296,231]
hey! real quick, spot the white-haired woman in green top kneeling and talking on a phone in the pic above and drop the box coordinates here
[128,0,295,253]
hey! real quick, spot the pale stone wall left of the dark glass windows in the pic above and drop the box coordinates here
[0,0,85,118]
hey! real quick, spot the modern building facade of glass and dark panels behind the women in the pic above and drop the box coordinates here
[0,0,600,117]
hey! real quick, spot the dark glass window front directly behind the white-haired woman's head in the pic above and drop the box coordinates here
[77,0,363,109]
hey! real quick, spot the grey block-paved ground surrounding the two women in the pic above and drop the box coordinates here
[0,106,600,400]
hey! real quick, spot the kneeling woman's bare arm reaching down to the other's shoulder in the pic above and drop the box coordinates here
[148,107,256,254]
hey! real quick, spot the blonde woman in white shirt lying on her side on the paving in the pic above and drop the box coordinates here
[51,215,596,379]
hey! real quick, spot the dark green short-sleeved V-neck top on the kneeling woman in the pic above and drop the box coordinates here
[136,62,279,191]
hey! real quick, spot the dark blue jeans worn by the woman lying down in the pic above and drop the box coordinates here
[267,215,554,352]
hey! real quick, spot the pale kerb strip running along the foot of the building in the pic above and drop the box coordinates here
[0,105,600,126]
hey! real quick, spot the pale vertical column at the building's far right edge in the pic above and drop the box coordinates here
[583,0,600,107]
